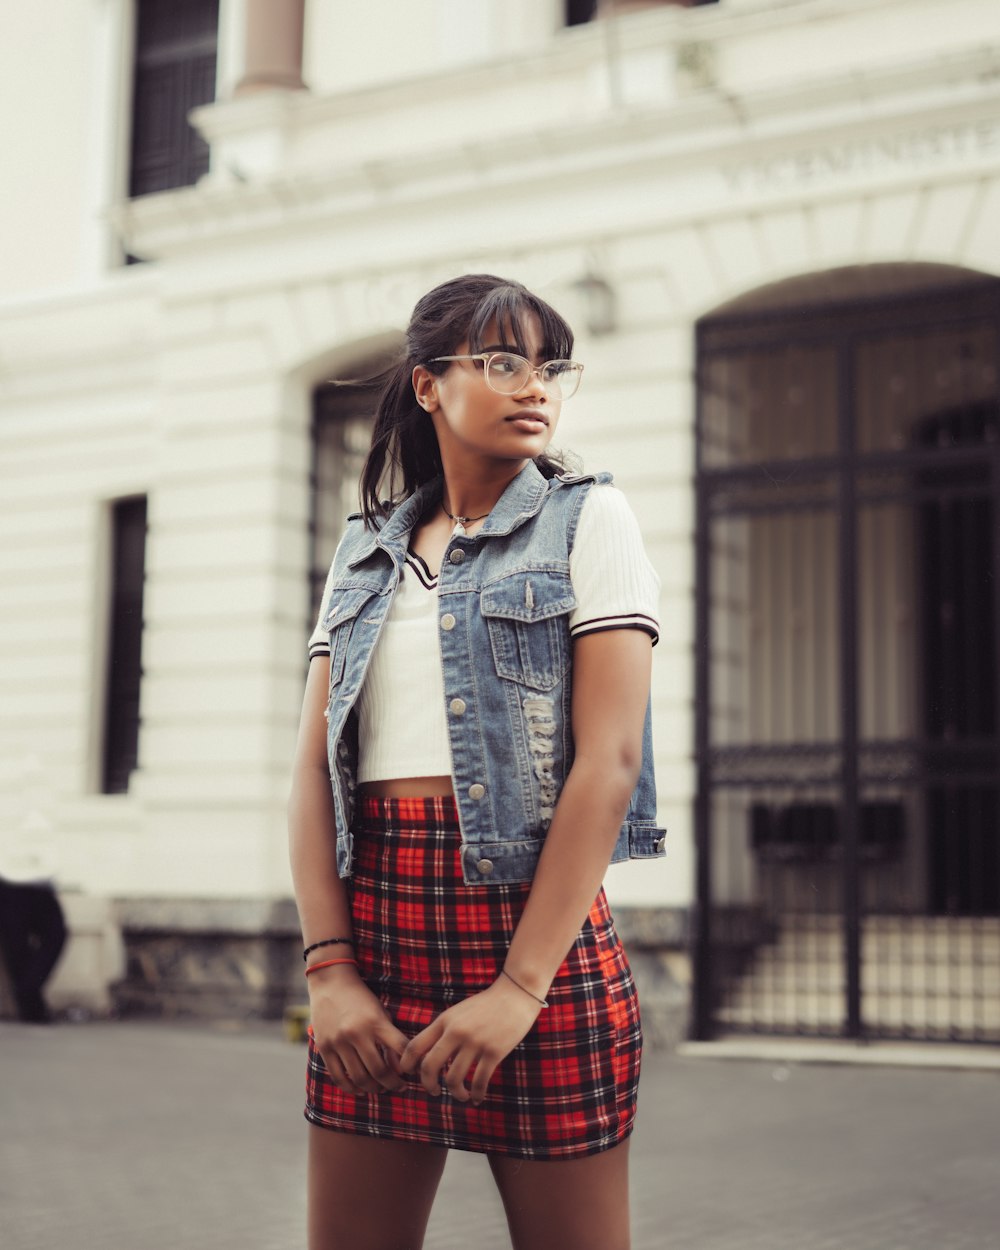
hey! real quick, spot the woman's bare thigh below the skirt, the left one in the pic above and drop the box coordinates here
[309,1125,448,1250]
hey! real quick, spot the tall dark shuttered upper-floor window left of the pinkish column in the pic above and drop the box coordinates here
[129,0,219,196]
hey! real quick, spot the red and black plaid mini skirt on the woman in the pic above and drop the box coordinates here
[305,796,643,1159]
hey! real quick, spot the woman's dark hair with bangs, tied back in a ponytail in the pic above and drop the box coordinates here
[360,274,573,528]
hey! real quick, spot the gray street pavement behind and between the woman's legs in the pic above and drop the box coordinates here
[0,1023,1000,1250]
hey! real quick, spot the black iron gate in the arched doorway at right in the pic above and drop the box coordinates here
[694,278,1000,1041]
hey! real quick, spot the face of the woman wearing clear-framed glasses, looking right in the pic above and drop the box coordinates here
[414,318,561,465]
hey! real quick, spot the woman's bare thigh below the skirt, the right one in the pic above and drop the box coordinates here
[490,1138,630,1250]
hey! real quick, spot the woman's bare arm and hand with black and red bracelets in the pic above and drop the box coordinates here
[289,656,406,1094]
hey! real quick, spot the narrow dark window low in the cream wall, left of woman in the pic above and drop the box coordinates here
[101,496,146,794]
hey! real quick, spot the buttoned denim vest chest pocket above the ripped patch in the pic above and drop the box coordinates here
[479,569,576,690]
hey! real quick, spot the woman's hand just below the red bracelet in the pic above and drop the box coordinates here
[309,966,408,1094]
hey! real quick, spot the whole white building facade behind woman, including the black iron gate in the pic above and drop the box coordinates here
[0,0,1000,1040]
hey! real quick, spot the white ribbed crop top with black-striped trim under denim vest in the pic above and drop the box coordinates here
[309,485,660,784]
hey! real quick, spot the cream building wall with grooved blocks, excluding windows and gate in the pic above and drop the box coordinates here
[0,0,1000,1015]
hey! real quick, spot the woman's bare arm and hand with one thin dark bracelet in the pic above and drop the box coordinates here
[401,629,653,1103]
